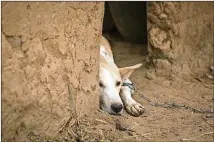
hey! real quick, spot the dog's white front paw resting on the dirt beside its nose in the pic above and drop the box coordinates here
[125,102,145,117]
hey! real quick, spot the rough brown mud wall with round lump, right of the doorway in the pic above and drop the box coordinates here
[147,2,214,77]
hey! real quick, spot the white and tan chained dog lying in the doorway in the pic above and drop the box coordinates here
[99,36,144,116]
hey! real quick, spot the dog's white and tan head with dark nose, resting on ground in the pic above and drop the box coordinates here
[99,64,142,114]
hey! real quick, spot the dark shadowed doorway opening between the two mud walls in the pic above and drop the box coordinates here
[103,2,148,50]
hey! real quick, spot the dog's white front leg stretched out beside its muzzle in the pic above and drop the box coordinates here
[120,79,145,116]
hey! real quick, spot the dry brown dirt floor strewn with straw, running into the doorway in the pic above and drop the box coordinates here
[50,33,214,142]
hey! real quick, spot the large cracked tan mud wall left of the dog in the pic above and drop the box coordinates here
[2,2,104,141]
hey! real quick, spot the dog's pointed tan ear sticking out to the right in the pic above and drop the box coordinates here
[119,63,142,80]
